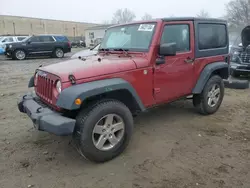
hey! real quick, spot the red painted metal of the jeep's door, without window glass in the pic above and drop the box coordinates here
[154,21,194,103]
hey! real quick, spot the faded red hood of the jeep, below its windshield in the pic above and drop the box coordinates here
[39,55,136,82]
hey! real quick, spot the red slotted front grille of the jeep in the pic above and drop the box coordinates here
[36,74,55,104]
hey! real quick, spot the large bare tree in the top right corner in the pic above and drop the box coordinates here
[226,0,250,27]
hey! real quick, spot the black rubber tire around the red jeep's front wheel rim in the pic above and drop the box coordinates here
[73,99,133,162]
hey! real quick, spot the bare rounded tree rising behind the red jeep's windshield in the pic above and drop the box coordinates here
[112,8,135,24]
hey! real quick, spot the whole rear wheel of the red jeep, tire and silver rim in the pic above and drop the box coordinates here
[193,75,224,115]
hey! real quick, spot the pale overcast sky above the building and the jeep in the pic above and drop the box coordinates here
[0,0,229,23]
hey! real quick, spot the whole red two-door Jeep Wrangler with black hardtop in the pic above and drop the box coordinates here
[18,18,229,162]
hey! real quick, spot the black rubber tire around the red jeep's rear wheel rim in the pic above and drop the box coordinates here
[193,75,224,115]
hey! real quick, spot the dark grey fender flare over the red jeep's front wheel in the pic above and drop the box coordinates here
[56,78,145,111]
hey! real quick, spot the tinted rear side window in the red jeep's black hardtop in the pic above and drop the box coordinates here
[198,23,227,50]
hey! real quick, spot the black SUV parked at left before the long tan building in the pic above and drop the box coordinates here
[5,35,71,60]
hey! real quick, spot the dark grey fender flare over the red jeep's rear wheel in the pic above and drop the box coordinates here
[192,62,229,94]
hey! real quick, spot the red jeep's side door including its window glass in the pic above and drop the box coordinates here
[154,21,195,103]
